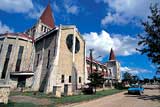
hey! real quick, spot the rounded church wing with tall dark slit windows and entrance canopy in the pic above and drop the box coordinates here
[0,33,34,88]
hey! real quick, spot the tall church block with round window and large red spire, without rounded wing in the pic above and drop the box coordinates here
[29,4,86,96]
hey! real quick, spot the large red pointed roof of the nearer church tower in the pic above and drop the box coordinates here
[40,4,55,28]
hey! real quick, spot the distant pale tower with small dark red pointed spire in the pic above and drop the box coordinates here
[107,48,120,81]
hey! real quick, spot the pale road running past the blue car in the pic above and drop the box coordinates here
[66,86,160,107]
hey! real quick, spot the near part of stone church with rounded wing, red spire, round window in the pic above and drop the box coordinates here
[0,4,87,93]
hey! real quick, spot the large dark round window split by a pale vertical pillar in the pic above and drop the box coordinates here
[66,34,80,53]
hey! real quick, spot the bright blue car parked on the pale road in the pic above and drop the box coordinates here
[128,84,144,95]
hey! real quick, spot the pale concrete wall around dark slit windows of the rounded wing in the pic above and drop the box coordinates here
[0,35,33,80]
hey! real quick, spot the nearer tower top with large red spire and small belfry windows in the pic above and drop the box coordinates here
[26,4,55,39]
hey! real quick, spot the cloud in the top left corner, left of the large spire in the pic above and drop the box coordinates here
[0,0,44,19]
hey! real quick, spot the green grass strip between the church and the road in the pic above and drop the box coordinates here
[0,89,124,107]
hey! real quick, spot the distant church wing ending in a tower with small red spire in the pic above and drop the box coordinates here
[86,49,120,85]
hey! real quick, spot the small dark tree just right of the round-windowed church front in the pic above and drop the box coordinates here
[88,72,105,93]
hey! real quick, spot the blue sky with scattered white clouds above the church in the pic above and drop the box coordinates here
[0,0,160,79]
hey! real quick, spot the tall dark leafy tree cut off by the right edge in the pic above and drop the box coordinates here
[137,4,160,69]
